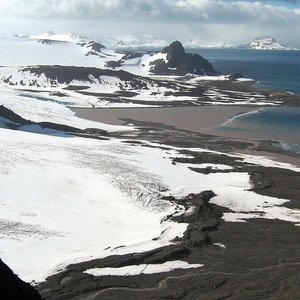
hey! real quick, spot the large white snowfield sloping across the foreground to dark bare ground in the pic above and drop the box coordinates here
[0,120,300,281]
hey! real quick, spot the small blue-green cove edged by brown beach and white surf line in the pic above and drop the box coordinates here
[217,107,300,146]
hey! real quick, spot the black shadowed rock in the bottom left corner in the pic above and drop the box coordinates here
[0,259,42,300]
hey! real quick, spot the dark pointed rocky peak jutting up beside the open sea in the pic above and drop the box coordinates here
[151,41,216,75]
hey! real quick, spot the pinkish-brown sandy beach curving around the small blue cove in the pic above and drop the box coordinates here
[72,105,300,166]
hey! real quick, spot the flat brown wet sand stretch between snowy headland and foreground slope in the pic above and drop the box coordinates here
[72,105,300,143]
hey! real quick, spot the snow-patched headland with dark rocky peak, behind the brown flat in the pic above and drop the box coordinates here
[0,32,276,107]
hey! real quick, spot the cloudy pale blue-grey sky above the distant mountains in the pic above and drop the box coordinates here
[0,0,300,48]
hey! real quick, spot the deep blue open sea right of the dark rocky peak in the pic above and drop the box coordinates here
[187,49,300,94]
